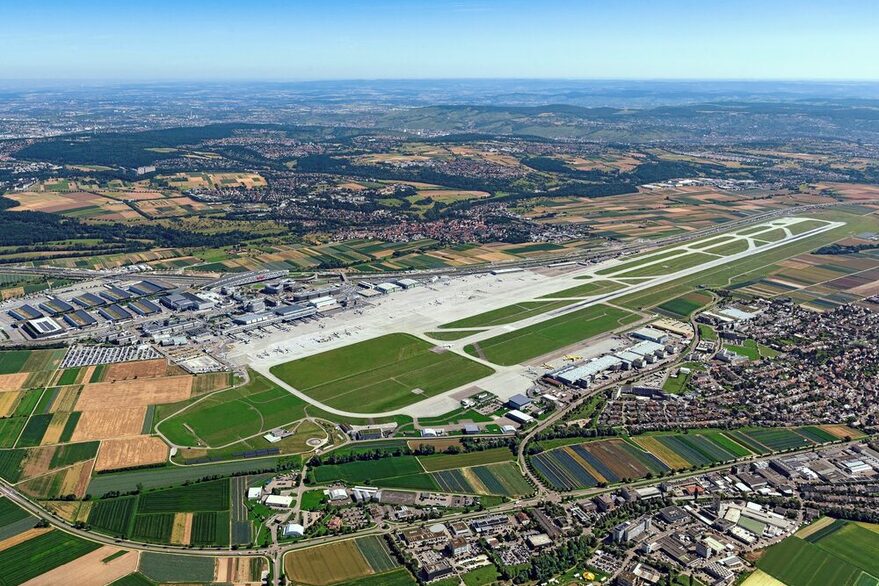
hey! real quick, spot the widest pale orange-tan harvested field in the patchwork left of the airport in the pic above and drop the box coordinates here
[76,375,192,411]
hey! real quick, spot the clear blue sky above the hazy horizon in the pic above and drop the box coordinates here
[0,0,879,80]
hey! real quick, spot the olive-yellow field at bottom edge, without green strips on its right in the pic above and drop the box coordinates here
[284,539,373,586]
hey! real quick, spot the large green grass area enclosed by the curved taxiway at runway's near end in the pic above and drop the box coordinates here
[271,334,494,413]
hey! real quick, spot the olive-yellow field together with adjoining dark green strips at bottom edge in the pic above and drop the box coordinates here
[284,537,398,586]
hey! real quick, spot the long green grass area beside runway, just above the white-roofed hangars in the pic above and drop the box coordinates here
[465,305,638,366]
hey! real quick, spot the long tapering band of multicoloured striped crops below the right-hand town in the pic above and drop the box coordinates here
[530,427,856,490]
